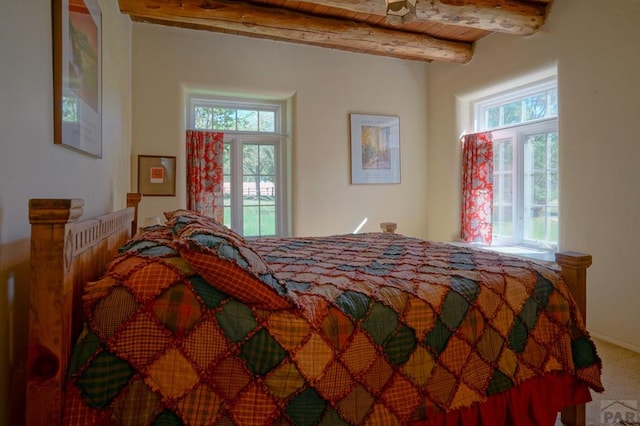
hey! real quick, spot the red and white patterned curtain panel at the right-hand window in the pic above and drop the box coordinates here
[462,132,493,244]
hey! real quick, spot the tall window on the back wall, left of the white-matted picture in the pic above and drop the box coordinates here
[189,96,287,237]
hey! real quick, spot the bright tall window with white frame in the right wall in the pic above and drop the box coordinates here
[473,78,559,249]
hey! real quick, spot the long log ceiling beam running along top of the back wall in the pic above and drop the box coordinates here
[119,0,473,63]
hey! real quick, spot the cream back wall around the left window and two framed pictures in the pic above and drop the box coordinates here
[133,24,427,240]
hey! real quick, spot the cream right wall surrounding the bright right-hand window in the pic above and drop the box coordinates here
[427,0,640,351]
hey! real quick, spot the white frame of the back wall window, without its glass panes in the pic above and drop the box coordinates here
[187,95,290,236]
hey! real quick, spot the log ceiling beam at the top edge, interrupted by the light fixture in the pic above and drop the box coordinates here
[284,0,551,35]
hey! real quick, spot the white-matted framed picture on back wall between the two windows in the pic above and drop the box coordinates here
[350,114,400,184]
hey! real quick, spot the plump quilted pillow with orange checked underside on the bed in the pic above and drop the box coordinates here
[167,211,294,310]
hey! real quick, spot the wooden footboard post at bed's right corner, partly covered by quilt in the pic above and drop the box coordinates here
[556,252,592,426]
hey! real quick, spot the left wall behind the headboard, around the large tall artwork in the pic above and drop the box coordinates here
[0,0,131,424]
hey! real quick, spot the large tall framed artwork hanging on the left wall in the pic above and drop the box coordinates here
[52,0,102,158]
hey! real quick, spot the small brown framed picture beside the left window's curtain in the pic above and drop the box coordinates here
[138,155,176,196]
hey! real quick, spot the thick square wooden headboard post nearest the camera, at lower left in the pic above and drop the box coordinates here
[26,199,84,426]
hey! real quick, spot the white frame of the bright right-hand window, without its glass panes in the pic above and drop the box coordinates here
[470,74,559,251]
